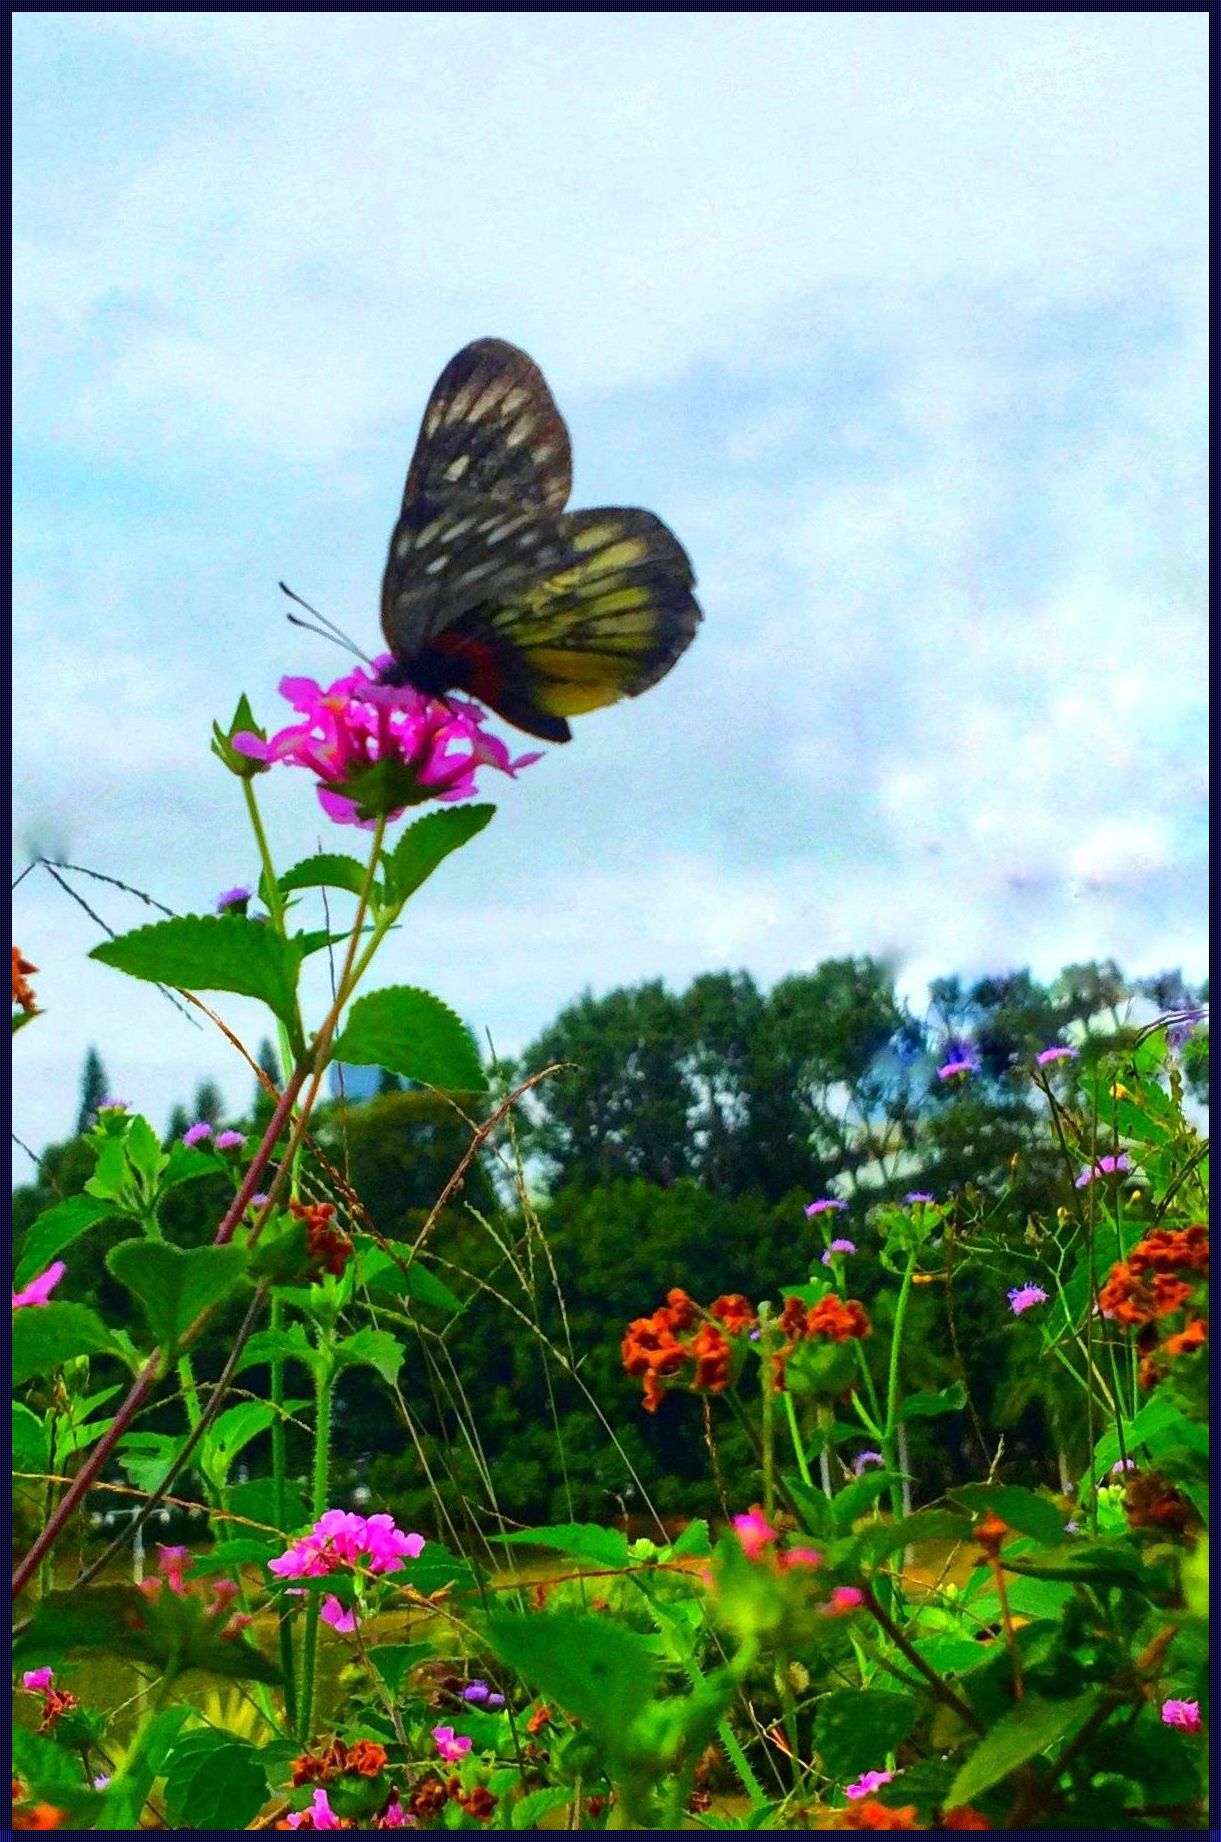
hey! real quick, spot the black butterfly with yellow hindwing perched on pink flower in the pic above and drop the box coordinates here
[381,339,702,742]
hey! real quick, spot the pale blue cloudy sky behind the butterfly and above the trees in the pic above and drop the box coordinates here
[13,13,1208,1177]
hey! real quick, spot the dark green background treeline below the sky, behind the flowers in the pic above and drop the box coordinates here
[13,958,1206,1527]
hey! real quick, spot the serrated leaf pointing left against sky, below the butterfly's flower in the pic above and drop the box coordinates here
[90,915,298,1028]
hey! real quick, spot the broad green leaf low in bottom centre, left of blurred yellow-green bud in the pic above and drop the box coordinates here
[486,1612,657,1750]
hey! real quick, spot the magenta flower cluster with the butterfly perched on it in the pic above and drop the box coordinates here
[232,658,540,827]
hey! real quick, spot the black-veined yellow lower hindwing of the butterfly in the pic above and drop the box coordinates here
[403,507,702,742]
